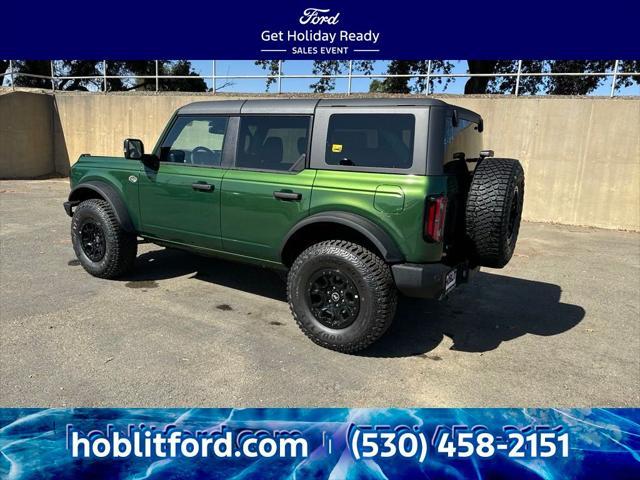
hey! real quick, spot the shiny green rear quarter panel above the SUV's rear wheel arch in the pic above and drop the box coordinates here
[309,170,447,263]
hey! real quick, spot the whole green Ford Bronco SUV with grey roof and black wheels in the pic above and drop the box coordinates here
[64,98,524,352]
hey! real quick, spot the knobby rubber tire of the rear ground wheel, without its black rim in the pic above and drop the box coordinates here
[287,240,398,353]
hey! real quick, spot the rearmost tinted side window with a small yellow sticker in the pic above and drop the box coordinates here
[325,113,415,169]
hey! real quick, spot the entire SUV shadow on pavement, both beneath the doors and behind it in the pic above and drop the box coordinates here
[122,249,585,360]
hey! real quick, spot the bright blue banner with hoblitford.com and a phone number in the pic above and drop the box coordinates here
[0,408,640,479]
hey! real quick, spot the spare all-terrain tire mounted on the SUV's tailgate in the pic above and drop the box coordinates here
[465,158,524,268]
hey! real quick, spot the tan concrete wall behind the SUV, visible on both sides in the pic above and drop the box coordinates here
[0,93,640,231]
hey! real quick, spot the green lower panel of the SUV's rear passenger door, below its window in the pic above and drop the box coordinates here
[221,170,316,262]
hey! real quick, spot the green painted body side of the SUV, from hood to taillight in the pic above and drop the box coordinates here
[71,127,447,266]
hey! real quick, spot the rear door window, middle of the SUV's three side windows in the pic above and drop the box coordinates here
[236,115,310,172]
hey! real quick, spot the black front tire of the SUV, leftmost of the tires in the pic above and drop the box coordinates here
[71,199,138,278]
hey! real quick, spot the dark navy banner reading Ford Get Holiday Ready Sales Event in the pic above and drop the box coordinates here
[0,0,640,60]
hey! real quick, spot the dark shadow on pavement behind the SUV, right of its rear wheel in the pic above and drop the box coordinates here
[359,272,585,360]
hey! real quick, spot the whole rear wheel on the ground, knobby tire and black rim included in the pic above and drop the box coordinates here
[287,240,397,353]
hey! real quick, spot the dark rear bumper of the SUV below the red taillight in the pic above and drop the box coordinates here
[391,263,478,299]
